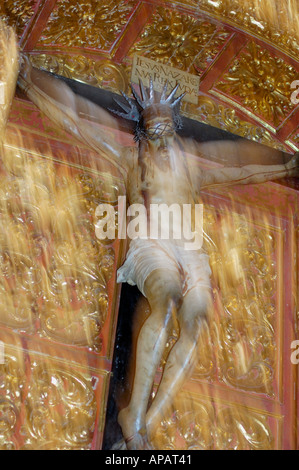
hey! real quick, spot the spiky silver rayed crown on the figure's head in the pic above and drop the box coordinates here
[110,78,186,140]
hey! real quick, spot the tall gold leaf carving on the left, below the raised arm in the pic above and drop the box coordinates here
[0,138,117,351]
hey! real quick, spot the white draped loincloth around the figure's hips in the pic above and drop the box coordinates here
[117,238,211,296]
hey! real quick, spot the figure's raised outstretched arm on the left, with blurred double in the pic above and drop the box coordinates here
[18,56,130,176]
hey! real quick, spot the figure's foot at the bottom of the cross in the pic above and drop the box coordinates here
[118,407,152,450]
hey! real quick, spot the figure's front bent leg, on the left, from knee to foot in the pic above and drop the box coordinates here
[118,269,182,450]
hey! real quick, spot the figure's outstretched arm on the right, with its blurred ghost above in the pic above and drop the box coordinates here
[200,141,299,187]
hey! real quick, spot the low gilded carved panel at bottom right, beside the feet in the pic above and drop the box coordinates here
[153,392,280,451]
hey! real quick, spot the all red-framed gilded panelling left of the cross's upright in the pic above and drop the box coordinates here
[0,119,126,450]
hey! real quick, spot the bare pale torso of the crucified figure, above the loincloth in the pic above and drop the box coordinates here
[127,136,203,244]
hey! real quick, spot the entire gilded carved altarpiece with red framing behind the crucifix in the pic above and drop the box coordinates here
[0,0,299,449]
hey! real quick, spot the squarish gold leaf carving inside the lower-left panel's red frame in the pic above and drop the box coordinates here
[22,359,96,450]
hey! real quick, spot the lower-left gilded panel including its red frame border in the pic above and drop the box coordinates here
[0,330,107,450]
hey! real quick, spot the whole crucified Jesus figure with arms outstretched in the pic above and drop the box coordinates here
[18,57,298,449]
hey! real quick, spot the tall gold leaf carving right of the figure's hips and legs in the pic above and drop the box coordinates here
[194,207,279,395]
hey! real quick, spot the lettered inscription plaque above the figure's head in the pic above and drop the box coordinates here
[131,54,199,104]
